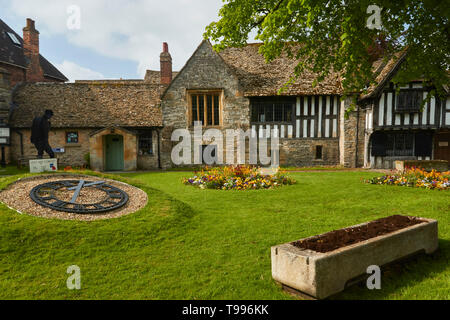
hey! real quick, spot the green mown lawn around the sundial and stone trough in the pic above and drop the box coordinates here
[0,171,450,299]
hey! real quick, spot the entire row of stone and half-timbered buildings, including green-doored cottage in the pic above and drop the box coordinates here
[0,18,450,171]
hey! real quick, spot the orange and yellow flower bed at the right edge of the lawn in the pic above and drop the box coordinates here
[366,168,450,190]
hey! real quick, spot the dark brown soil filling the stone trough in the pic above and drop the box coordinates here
[292,215,425,253]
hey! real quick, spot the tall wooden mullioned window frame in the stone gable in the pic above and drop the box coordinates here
[187,89,223,128]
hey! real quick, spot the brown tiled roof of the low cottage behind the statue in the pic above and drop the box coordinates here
[10,80,164,128]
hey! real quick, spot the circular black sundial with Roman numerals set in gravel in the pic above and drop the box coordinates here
[30,180,128,214]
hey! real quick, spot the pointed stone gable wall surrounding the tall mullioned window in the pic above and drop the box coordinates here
[161,41,250,168]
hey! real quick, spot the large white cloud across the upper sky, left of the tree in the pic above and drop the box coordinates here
[7,0,222,77]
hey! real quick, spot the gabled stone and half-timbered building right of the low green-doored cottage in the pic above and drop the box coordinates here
[161,41,450,168]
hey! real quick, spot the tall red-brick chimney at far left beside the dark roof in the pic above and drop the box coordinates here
[23,18,44,82]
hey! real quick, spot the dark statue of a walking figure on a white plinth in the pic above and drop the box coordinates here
[31,110,55,159]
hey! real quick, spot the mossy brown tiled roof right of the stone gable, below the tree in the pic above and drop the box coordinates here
[219,43,342,96]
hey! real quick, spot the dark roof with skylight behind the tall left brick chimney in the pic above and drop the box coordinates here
[0,19,68,81]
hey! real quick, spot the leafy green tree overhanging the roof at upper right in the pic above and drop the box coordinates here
[204,0,450,100]
